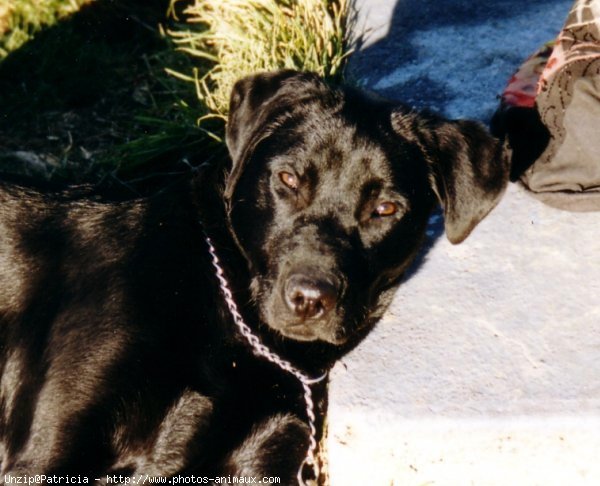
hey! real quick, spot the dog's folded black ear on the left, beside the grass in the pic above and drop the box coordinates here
[225,70,324,200]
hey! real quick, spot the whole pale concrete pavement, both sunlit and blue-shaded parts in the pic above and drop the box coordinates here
[328,0,600,486]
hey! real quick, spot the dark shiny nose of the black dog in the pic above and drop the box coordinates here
[285,273,338,321]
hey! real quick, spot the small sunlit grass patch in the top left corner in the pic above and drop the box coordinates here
[0,0,94,59]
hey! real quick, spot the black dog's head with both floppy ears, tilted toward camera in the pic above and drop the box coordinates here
[225,71,508,345]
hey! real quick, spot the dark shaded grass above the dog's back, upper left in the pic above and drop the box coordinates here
[0,0,216,192]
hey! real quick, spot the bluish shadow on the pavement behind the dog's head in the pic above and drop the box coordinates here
[349,0,572,122]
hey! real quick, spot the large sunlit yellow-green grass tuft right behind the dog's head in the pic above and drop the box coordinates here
[169,0,349,119]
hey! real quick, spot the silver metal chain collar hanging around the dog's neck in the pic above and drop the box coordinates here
[204,233,327,486]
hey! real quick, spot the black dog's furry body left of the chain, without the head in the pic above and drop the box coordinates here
[1,178,304,478]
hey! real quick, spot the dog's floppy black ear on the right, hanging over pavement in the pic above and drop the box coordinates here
[392,110,510,244]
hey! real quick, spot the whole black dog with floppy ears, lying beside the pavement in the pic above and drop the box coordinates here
[0,71,509,484]
